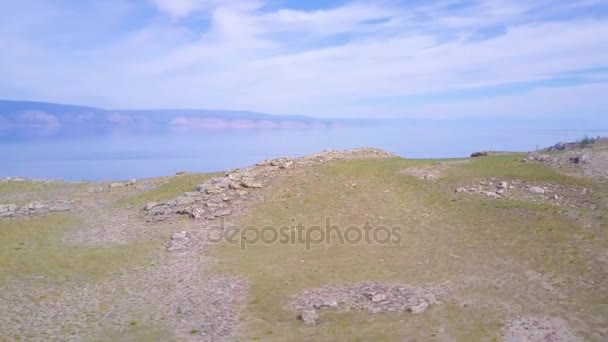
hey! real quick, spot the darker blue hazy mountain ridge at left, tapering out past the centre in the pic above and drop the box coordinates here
[0,100,337,134]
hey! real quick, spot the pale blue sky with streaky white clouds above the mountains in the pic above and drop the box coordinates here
[0,0,608,121]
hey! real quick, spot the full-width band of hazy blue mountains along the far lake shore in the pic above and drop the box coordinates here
[0,100,608,140]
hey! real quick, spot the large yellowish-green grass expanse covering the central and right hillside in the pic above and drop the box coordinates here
[215,155,608,341]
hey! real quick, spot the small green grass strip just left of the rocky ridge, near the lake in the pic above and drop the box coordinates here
[117,173,220,206]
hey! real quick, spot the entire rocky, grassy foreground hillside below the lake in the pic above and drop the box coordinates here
[0,141,608,341]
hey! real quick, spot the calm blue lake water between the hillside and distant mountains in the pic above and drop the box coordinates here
[0,125,608,181]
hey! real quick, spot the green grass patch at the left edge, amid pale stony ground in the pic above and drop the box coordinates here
[0,214,155,281]
